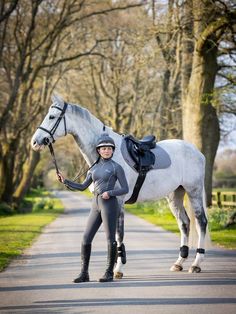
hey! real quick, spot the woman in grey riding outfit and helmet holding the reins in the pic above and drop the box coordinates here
[58,133,129,283]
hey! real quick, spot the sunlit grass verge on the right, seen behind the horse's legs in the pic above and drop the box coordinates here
[126,200,236,249]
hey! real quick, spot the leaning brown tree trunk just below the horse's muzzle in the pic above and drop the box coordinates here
[13,149,40,206]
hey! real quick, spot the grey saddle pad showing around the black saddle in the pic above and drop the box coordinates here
[120,139,171,171]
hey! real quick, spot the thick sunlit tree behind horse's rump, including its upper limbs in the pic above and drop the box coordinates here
[182,0,236,205]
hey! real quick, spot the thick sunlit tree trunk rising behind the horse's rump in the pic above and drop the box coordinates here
[182,0,220,205]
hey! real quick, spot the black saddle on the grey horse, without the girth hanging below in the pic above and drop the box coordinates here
[124,135,156,172]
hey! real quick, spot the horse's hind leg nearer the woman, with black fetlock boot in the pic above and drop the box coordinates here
[167,186,190,271]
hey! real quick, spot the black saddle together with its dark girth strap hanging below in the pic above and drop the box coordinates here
[124,135,156,204]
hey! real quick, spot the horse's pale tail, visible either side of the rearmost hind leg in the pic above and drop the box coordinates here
[185,185,212,248]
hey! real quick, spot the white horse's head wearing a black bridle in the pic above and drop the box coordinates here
[31,96,67,151]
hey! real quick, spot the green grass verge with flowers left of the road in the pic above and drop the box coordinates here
[0,190,64,271]
